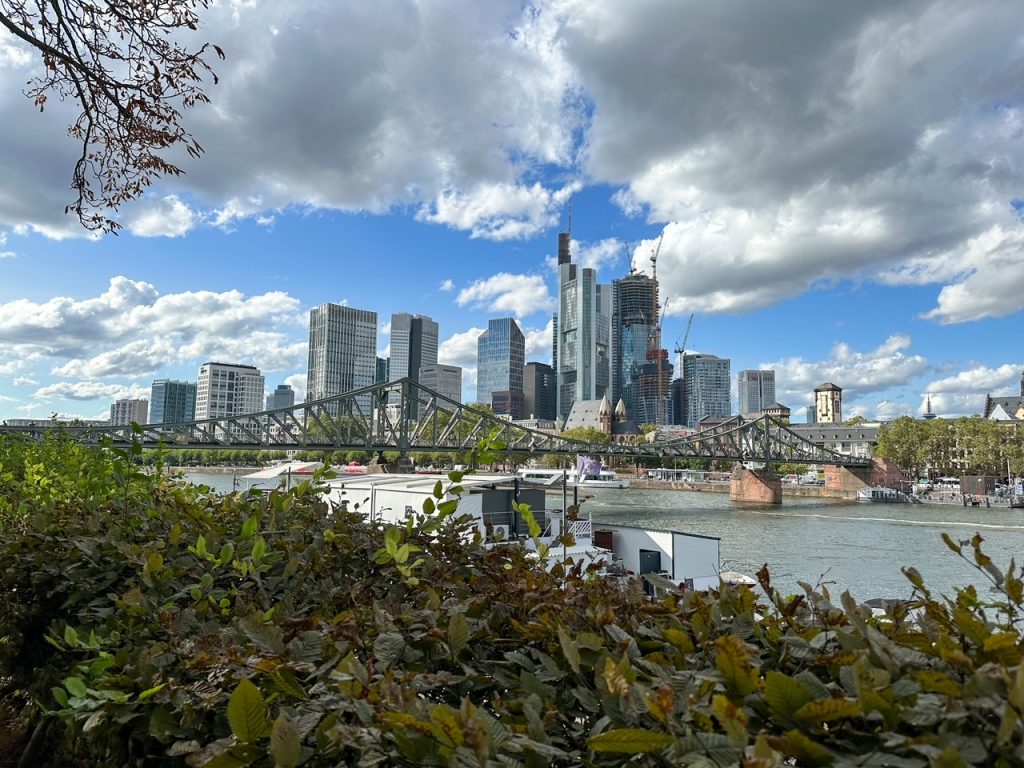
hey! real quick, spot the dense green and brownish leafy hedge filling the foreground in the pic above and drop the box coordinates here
[0,437,1024,768]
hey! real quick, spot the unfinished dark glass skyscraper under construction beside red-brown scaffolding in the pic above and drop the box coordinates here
[609,272,673,424]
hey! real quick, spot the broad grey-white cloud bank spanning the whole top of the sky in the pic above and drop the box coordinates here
[0,0,1024,324]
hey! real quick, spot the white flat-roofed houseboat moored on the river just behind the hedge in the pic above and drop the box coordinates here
[328,474,721,589]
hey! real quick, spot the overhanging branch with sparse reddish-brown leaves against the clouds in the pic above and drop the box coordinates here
[0,0,224,232]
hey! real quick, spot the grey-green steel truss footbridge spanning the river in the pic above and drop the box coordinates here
[0,379,870,467]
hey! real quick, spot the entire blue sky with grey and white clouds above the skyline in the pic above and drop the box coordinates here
[0,0,1024,418]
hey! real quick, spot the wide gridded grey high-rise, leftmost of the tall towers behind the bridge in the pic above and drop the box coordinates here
[306,304,377,411]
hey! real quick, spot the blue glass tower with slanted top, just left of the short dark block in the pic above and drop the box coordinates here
[476,317,526,419]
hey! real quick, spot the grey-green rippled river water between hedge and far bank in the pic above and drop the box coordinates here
[180,473,1024,601]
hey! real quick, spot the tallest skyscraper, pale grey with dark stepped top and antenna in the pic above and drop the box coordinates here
[552,232,611,419]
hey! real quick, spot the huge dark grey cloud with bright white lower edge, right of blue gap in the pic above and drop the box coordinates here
[559,0,1024,323]
